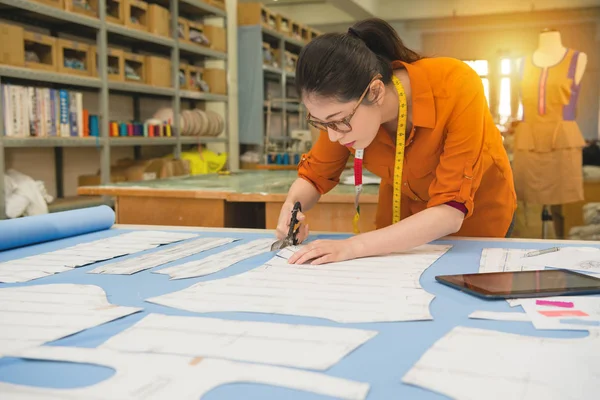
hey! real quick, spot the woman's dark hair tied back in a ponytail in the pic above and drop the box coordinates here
[296,18,421,102]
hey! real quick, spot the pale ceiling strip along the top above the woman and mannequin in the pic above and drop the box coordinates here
[238,0,600,26]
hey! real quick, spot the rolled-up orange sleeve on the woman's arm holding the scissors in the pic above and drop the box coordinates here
[298,131,350,194]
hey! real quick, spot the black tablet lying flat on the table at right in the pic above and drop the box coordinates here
[435,269,600,299]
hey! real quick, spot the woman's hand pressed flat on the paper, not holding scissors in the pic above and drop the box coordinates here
[288,239,357,265]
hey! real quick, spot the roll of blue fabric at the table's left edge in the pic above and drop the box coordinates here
[0,205,115,251]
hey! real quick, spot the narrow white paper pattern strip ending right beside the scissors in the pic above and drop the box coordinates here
[153,239,274,279]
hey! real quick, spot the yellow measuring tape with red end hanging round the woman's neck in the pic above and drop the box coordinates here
[352,75,408,234]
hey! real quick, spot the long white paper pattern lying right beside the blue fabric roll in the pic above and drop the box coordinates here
[0,231,198,283]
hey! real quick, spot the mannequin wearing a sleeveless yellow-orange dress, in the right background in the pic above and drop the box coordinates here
[513,30,587,237]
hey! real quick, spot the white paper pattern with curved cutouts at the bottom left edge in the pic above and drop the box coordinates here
[0,346,370,400]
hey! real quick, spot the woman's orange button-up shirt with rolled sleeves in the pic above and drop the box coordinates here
[298,58,517,237]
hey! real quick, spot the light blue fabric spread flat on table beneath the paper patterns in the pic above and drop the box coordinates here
[0,229,587,400]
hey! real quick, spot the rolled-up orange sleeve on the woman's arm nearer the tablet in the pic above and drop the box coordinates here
[427,68,491,218]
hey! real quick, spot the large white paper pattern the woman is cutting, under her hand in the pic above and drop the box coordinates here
[146,245,452,323]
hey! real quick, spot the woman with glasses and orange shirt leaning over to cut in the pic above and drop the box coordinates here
[277,19,516,264]
